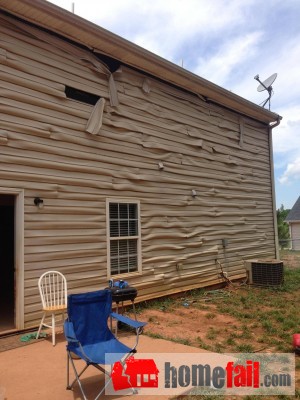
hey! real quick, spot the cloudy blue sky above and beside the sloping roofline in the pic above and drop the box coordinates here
[51,0,300,209]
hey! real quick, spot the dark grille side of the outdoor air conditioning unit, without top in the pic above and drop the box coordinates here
[251,262,284,286]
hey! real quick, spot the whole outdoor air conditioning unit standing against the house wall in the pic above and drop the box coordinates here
[245,259,284,286]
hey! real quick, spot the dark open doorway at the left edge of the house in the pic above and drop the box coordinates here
[0,194,16,332]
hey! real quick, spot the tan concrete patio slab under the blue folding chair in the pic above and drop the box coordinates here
[0,334,205,400]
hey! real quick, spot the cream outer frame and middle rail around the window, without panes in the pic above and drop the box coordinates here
[106,198,142,279]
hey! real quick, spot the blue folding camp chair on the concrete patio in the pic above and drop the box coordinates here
[64,290,146,400]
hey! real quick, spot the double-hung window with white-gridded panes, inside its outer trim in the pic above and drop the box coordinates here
[107,200,141,276]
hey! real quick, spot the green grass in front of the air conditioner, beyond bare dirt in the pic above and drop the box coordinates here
[199,269,300,352]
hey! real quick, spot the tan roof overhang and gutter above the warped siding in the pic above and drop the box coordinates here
[0,0,281,124]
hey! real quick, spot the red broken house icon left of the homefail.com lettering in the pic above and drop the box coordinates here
[111,356,159,390]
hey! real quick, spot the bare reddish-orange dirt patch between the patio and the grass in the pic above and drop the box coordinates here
[134,289,273,353]
